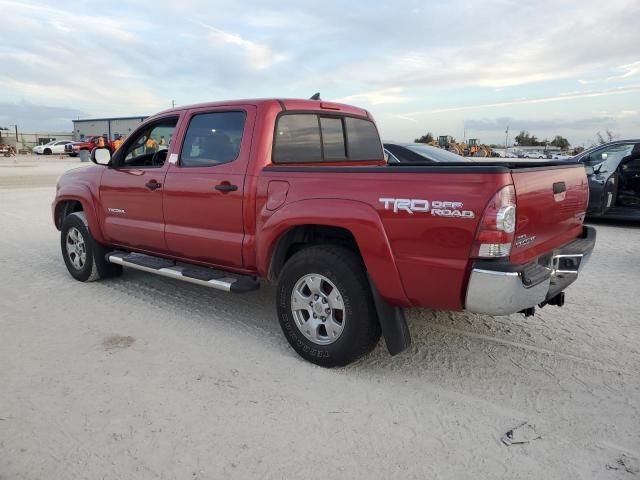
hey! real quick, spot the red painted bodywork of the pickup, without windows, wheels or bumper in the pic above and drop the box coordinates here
[53,100,588,310]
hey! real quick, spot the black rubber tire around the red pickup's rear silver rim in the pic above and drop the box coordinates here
[277,245,380,367]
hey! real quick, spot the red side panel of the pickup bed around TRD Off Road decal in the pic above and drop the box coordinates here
[256,171,511,310]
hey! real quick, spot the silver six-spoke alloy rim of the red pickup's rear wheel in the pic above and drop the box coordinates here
[291,273,346,345]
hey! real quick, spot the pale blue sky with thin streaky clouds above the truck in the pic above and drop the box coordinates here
[0,0,640,146]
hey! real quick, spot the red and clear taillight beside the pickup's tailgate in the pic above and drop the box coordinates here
[471,185,516,258]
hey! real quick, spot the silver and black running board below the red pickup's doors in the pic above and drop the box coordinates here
[105,251,260,293]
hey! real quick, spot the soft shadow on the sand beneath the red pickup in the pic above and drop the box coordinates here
[117,271,632,381]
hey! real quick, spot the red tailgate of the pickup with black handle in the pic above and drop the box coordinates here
[511,164,589,263]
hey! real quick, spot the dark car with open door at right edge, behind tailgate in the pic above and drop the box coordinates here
[571,140,640,220]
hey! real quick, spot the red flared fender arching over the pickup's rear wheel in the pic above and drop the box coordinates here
[256,199,410,306]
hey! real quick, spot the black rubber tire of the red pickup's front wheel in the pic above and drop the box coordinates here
[60,212,122,282]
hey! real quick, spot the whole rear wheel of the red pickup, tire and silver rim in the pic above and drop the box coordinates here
[277,245,380,367]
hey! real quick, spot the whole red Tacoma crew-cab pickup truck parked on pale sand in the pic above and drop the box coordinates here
[52,99,595,366]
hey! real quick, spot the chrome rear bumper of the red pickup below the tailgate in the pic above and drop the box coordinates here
[465,227,596,315]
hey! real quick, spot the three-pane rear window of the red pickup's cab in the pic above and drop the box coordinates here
[273,113,384,163]
